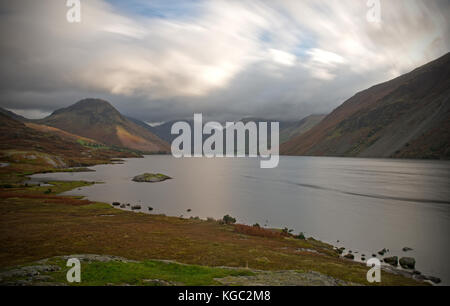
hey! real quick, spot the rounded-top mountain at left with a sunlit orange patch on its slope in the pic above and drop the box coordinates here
[35,99,169,153]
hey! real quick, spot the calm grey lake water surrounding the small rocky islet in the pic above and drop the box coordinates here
[33,156,450,284]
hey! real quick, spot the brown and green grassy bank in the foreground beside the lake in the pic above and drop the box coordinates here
[0,164,421,285]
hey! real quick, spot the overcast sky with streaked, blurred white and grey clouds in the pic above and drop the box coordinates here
[0,0,450,122]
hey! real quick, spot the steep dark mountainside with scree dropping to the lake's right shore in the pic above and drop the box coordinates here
[281,53,450,159]
